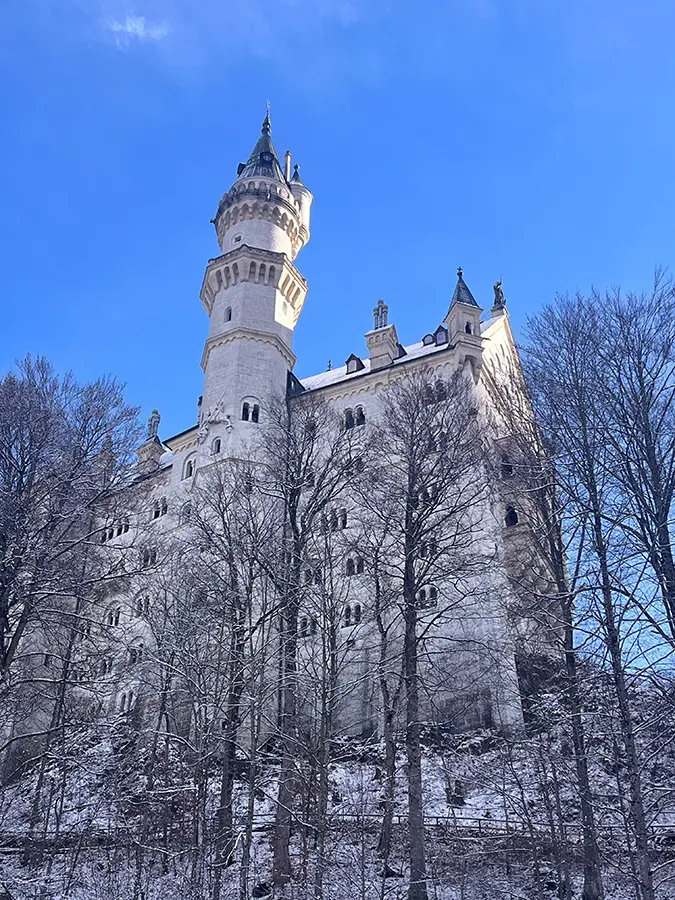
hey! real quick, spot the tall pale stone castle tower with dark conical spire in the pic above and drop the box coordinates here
[194,112,313,461]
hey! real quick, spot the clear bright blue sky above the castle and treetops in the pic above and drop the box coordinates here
[0,0,675,436]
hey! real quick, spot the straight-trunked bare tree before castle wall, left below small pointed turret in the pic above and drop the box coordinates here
[360,370,496,900]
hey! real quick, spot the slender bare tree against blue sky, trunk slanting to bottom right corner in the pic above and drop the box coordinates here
[526,296,654,900]
